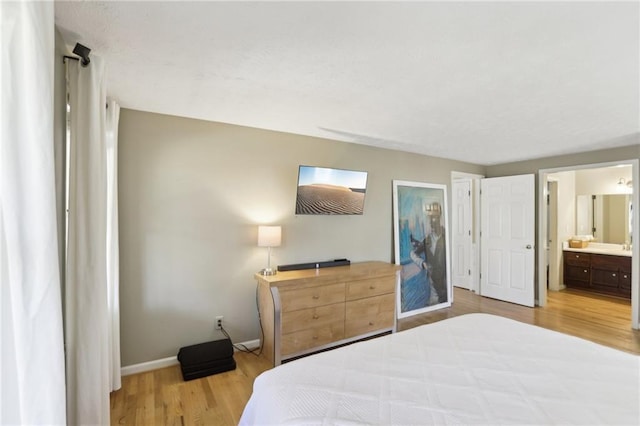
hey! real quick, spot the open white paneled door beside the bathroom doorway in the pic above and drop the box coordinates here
[480,175,535,306]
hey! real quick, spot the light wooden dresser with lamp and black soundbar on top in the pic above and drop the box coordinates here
[255,262,399,365]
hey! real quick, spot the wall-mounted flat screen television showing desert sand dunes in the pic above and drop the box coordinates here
[296,166,367,215]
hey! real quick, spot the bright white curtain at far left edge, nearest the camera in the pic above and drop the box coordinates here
[0,2,66,425]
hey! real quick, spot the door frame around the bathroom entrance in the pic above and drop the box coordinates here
[536,159,640,330]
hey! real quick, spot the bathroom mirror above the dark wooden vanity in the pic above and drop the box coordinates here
[576,194,633,244]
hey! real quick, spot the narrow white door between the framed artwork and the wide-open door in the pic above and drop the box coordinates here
[451,179,472,290]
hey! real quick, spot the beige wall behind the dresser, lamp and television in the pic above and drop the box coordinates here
[119,109,485,366]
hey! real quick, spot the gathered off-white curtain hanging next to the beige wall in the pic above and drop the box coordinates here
[65,55,120,425]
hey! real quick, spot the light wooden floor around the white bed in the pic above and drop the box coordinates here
[111,288,640,425]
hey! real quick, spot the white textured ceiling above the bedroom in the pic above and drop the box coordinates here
[55,1,640,165]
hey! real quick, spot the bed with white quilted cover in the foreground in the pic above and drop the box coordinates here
[240,314,640,425]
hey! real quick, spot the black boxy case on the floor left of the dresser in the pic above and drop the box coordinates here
[178,339,236,381]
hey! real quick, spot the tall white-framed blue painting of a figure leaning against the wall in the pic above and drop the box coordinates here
[393,180,452,318]
